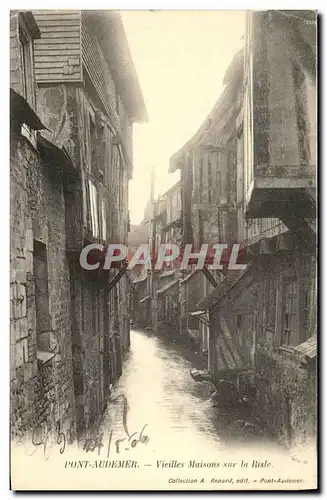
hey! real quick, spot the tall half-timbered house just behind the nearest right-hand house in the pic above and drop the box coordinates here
[169,49,244,350]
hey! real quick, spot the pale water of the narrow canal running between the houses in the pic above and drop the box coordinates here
[99,330,284,467]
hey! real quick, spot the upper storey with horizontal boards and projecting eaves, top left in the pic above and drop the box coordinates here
[33,10,147,122]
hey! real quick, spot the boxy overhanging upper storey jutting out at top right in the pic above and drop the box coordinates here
[244,11,316,218]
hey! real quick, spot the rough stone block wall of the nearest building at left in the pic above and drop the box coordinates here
[10,133,75,439]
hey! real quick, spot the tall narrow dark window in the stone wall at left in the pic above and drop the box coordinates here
[33,240,50,350]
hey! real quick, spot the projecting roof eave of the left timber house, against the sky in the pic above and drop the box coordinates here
[85,10,148,122]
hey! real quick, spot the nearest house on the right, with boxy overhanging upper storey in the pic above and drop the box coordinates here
[198,11,316,447]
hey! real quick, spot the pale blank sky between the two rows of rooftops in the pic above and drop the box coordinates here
[121,10,245,224]
